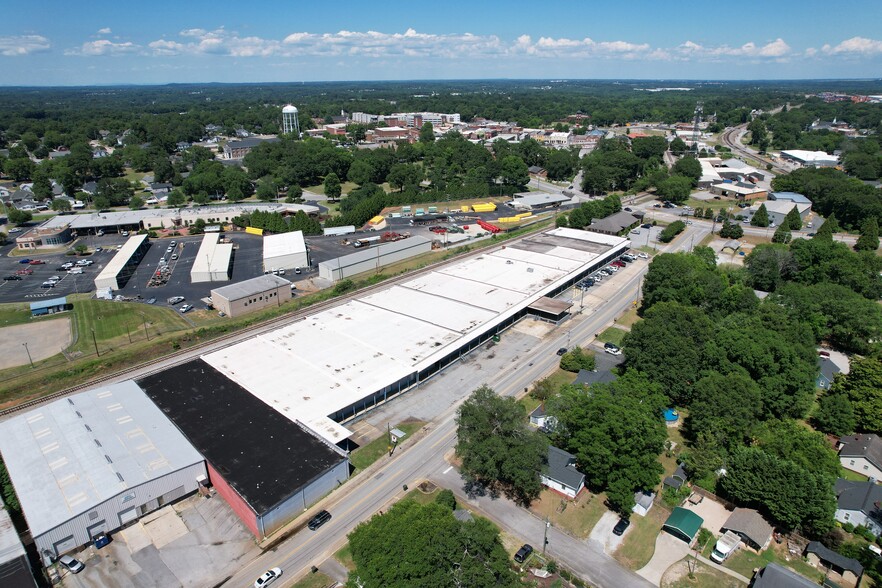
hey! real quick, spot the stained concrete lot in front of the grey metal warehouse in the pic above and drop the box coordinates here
[59,496,254,588]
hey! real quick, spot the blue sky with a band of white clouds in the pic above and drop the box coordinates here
[0,0,882,86]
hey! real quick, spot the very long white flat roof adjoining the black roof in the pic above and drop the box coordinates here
[202,228,629,443]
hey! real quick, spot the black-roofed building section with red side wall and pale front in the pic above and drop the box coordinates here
[138,359,349,538]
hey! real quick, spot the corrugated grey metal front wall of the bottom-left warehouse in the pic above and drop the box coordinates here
[35,461,206,557]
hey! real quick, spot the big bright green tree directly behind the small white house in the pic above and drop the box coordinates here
[547,372,667,513]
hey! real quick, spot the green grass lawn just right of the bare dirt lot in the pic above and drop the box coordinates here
[71,299,189,355]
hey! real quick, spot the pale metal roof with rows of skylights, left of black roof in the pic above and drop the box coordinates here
[0,380,203,536]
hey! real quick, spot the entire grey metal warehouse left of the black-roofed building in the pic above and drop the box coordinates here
[0,381,207,565]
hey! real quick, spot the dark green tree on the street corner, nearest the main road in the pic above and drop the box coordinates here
[456,386,548,504]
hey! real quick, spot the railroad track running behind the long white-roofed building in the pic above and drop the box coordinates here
[0,220,547,418]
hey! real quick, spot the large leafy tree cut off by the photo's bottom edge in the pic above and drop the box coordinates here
[349,500,519,588]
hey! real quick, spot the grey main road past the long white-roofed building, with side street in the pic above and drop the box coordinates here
[224,224,710,588]
